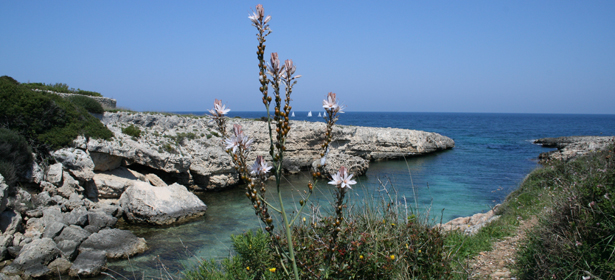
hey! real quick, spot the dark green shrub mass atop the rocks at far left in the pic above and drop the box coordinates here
[0,76,113,155]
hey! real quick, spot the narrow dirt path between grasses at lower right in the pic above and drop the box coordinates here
[469,217,538,279]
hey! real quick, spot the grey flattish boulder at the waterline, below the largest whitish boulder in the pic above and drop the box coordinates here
[79,228,147,259]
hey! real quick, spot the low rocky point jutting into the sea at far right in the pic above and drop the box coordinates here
[534,136,615,162]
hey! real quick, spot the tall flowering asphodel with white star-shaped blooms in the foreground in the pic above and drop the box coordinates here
[209,4,354,280]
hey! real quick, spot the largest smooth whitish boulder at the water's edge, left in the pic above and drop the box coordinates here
[120,182,207,225]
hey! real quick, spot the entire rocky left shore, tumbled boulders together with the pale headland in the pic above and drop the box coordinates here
[0,112,454,279]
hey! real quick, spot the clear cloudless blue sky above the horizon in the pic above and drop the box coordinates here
[0,1,615,114]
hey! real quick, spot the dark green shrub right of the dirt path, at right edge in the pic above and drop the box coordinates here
[518,148,615,279]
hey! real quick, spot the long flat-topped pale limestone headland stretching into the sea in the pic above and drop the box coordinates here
[84,112,455,189]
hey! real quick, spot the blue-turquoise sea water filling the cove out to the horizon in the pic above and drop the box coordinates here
[107,111,615,279]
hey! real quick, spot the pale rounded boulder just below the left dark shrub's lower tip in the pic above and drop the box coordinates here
[52,148,94,181]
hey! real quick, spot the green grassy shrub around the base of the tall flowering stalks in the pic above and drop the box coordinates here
[186,194,453,279]
